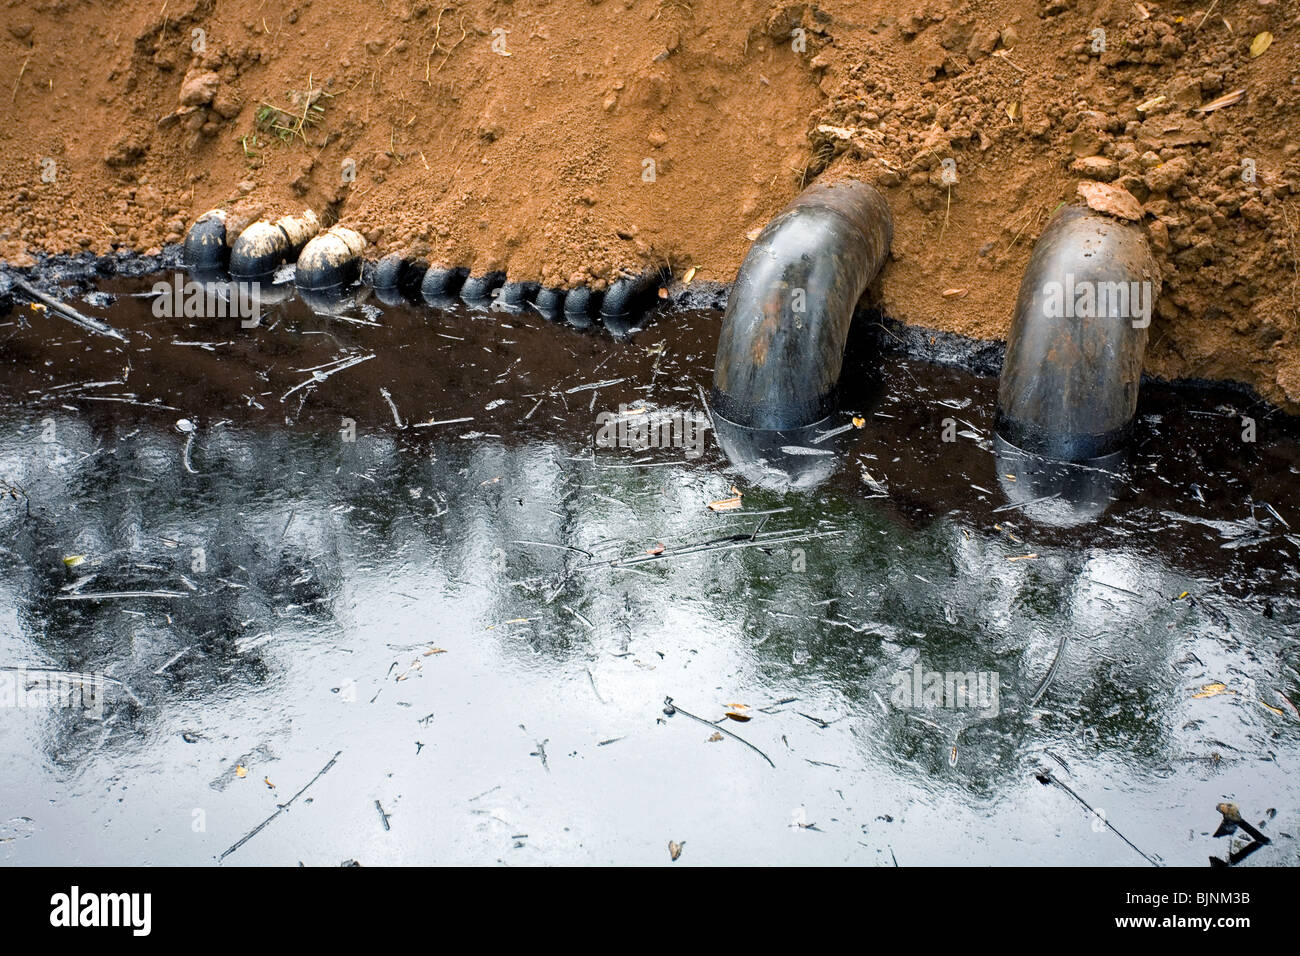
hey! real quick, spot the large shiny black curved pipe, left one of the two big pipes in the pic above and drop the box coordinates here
[712,179,893,429]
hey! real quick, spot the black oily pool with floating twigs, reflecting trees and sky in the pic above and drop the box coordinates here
[0,277,1300,865]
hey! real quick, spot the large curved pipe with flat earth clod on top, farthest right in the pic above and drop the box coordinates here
[997,206,1160,462]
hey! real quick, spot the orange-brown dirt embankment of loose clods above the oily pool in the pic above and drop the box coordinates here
[0,0,1300,411]
